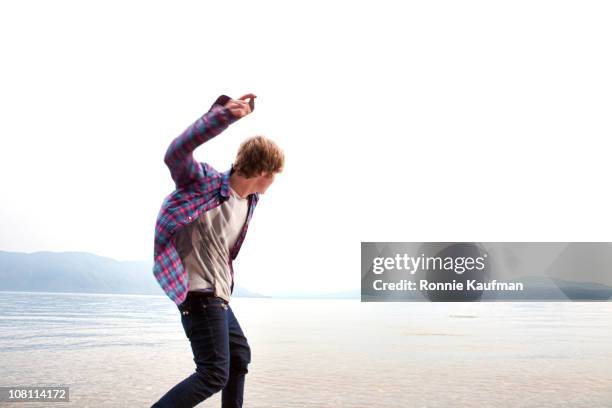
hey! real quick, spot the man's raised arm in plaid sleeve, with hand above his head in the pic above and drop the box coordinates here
[164,94,255,188]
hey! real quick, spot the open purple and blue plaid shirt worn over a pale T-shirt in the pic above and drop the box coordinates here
[153,95,259,305]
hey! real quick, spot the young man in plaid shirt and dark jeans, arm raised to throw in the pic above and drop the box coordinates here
[153,94,284,408]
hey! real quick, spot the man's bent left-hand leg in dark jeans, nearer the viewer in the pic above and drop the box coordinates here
[152,298,230,408]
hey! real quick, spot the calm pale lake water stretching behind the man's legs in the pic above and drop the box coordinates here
[0,292,612,408]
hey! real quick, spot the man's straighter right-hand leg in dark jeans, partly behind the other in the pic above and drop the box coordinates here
[221,306,251,408]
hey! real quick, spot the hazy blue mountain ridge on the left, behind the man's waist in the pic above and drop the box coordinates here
[0,251,264,297]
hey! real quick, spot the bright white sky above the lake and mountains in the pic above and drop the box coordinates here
[0,1,612,294]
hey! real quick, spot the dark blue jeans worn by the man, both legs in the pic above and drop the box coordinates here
[151,292,251,408]
